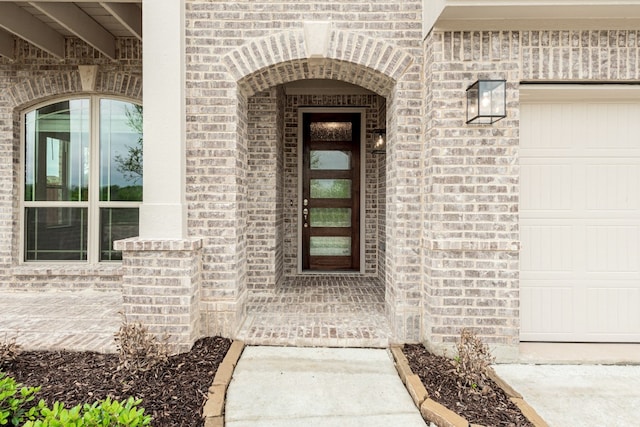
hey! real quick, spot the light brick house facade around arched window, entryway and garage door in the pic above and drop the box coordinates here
[5,4,640,354]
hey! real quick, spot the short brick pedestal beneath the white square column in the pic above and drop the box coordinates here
[114,238,202,353]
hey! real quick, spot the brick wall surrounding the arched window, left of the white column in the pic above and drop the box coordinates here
[0,38,142,290]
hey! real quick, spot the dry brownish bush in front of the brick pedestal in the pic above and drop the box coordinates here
[115,317,169,375]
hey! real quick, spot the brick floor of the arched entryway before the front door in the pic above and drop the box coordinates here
[238,276,391,347]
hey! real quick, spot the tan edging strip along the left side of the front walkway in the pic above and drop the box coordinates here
[202,341,244,427]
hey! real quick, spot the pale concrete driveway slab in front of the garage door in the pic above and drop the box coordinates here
[494,365,640,427]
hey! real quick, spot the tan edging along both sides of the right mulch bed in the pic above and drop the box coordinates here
[391,345,549,427]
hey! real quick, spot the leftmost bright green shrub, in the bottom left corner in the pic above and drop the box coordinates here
[0,372,40,426]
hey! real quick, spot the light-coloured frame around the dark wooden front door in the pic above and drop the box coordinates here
[296,107,367,275]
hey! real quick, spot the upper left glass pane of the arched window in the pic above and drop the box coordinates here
[24,99,89,202]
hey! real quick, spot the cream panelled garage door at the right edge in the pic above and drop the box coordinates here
[520,87,640,342]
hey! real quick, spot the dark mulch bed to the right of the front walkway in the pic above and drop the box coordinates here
[403,344,533,427]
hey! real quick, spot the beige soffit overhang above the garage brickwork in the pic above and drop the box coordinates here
[427,0,640,30]
